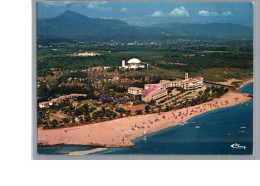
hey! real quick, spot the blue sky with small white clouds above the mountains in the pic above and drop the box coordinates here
[37,1,253,26]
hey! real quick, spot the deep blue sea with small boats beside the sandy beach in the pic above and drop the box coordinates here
[38,83,253,155]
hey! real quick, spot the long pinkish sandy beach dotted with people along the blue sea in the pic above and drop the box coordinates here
[38,91,252,147]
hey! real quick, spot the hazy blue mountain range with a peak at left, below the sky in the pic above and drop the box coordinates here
[37,11,253,42]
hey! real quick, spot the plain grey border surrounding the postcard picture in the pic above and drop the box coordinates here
[31,0,260,160]
